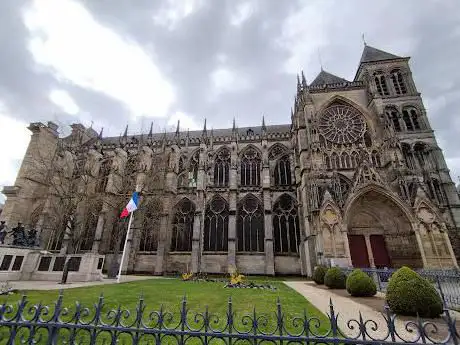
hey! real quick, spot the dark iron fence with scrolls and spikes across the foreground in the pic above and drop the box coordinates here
[0,294,460,345]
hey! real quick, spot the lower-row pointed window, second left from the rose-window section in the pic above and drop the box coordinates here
[237,194,265,252]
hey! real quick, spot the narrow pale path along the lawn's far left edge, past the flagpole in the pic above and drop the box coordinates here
[4,275,164,290]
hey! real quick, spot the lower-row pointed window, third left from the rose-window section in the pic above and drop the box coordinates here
[204,196,229,252]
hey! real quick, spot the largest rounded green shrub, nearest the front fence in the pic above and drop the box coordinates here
[386,266,443,318]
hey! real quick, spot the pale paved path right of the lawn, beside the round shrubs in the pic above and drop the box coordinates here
[284,281,457,342]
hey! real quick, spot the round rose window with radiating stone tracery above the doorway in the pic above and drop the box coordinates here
[319,105,366,144]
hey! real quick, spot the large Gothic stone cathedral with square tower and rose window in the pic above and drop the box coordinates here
[0,45,460,276]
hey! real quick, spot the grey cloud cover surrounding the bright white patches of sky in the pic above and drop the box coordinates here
[0,0,460,181]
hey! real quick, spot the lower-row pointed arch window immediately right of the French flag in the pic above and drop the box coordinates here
[139,199,162,252]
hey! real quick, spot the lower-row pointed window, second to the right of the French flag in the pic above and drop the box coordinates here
[171,199,195,252]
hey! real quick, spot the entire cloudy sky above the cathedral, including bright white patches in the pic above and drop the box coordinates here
[0,0,460,200]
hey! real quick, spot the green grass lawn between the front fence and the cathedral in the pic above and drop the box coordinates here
[0,279,328,344]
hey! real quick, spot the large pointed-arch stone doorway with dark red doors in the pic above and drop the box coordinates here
[346,190,423,268]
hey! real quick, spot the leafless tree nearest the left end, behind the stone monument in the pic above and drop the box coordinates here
[19,141,102,283]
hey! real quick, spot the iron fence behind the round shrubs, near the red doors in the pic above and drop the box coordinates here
[344,268,460,310]
